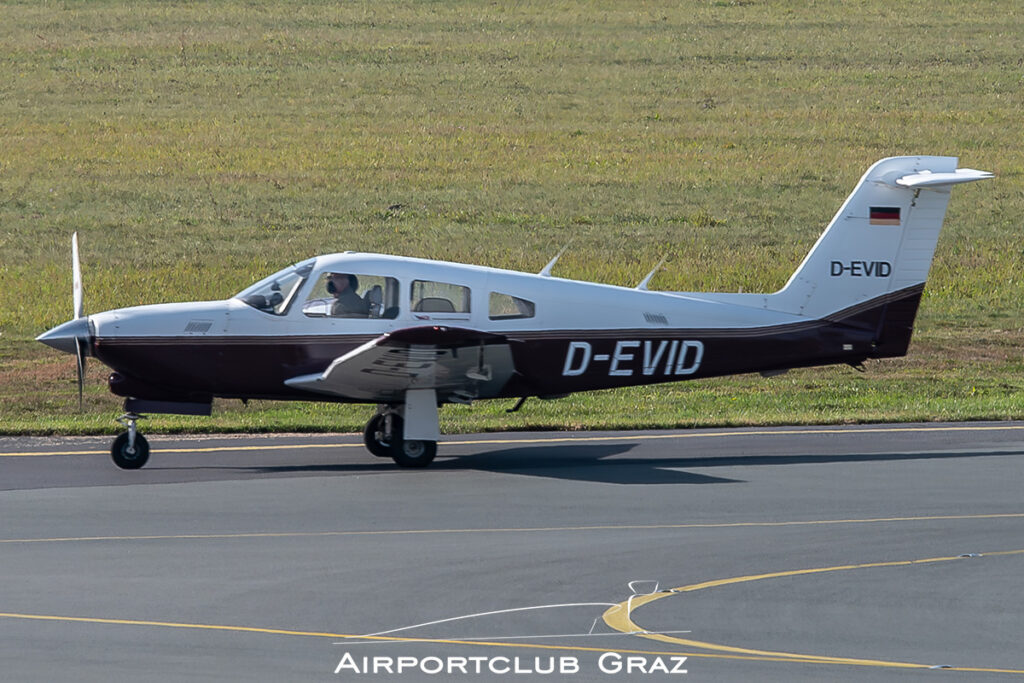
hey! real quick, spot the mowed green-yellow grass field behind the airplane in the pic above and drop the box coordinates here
[0,0,1024,432]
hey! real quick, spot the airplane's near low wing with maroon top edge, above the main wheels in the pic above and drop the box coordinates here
[285,326,515,402]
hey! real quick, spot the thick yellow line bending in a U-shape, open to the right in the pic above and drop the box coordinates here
[603,549,1024,675]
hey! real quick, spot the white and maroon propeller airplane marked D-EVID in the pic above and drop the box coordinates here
[37,157,993,469]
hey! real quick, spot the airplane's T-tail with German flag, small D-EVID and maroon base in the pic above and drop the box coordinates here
[714,157,992,357]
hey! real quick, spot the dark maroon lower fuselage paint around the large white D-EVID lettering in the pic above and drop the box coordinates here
[93,285,924,400]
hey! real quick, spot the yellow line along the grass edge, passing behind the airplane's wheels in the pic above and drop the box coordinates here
[0,425,1024,458]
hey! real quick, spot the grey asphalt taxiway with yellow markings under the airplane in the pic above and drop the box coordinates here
[0,423,1024,681]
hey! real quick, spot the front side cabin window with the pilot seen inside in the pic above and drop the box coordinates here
[302,270,398,318]
